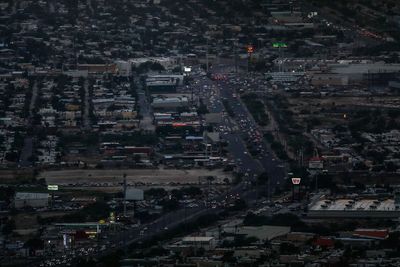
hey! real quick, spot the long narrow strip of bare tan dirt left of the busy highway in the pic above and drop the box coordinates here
[38,169,231,185]
